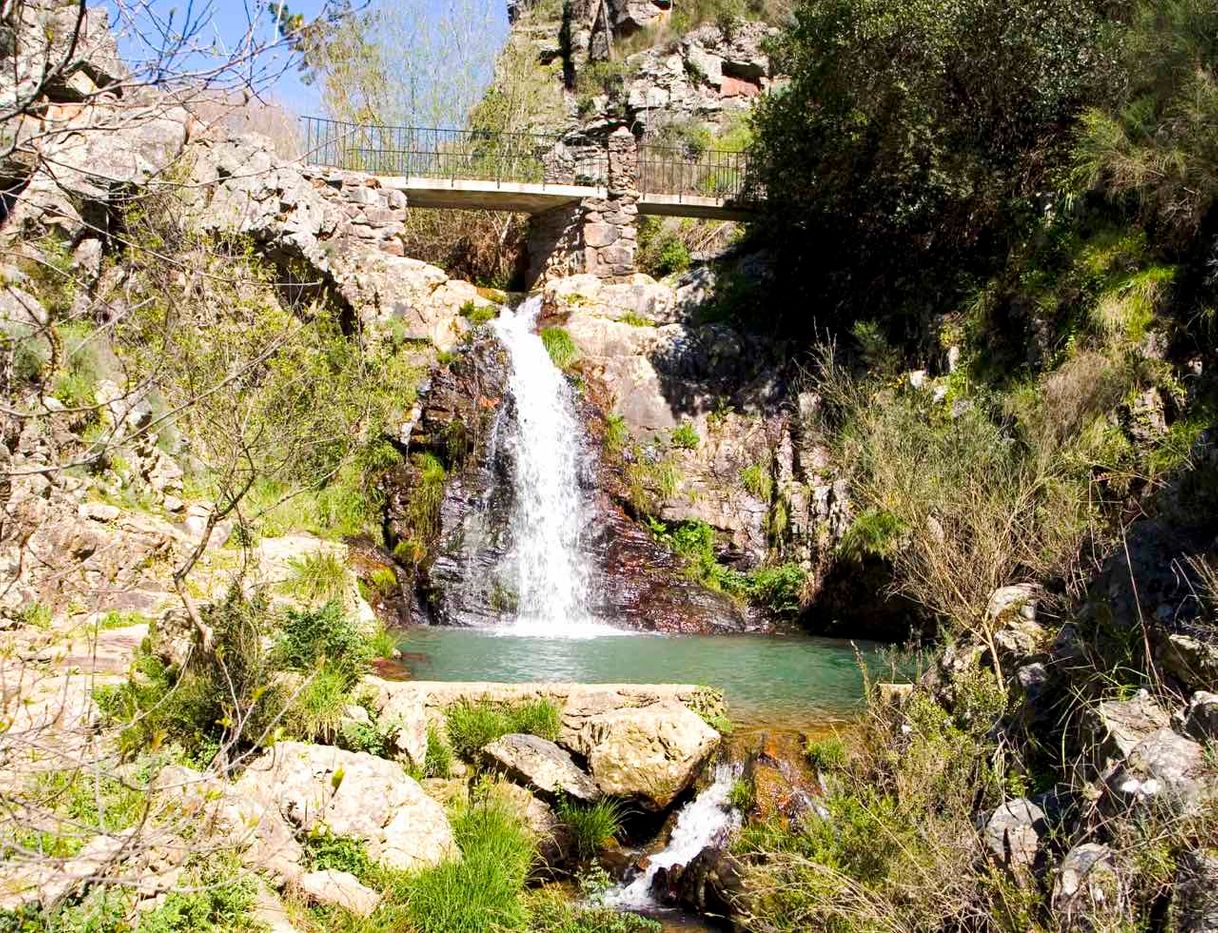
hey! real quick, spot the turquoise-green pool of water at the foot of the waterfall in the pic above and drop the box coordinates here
[401,627,876,725]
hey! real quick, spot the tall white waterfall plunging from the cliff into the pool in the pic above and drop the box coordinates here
[493,296,614,636]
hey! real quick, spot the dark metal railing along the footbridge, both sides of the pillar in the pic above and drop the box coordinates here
[301,117,752,201]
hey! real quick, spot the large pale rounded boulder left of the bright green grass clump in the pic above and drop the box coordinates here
[234,742,458,873]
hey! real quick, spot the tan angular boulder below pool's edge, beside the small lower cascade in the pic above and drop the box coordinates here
[561,702,720,810]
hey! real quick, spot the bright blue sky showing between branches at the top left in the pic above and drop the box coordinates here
[106,0,508,114]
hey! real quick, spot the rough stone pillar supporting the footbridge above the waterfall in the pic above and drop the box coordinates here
[529,127,638,287]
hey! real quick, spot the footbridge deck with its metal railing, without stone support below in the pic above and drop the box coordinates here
[302,117,754,220]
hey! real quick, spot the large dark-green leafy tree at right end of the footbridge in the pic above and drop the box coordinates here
[753,0,1106,341]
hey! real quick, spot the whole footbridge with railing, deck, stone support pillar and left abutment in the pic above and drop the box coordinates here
[303,117,755,285]
